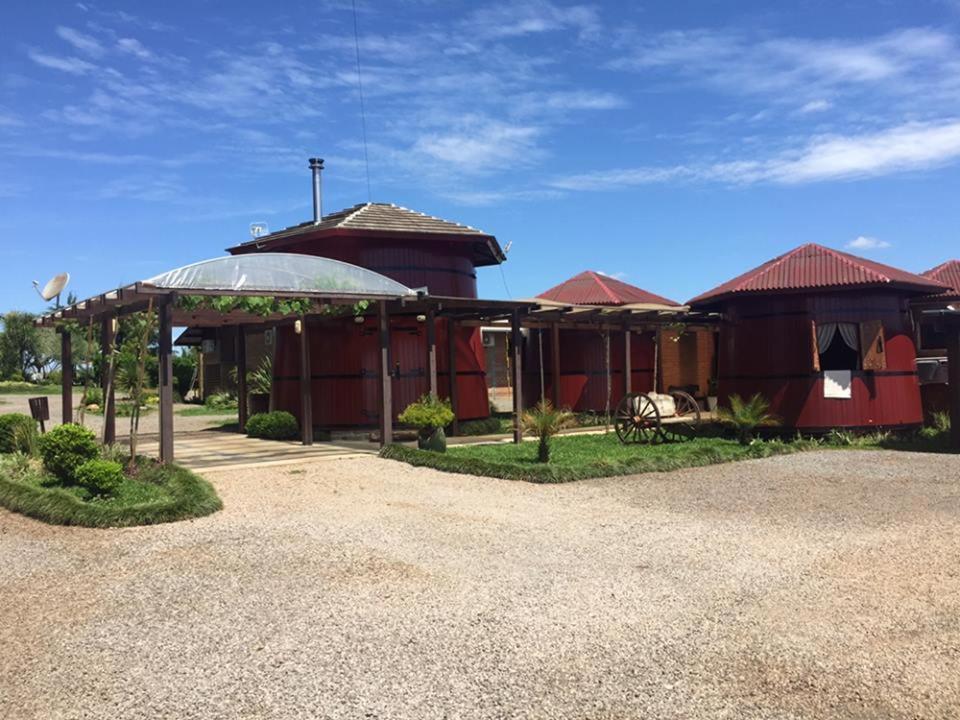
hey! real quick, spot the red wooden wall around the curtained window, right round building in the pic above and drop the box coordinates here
[718,290,923,430]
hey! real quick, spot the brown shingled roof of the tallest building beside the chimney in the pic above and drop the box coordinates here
[227,203,506,265]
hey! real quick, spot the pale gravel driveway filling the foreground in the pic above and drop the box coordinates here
[0,451,960,720]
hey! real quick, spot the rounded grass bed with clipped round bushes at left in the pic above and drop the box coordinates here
[0,455,223,527]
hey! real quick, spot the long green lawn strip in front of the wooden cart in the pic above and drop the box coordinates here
[381,433,819,483]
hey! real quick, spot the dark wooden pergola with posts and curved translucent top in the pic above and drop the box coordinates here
[37,253,717,462]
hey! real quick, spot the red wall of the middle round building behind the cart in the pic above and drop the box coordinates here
[523,329,654,412]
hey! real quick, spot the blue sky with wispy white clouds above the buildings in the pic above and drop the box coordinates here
[0,0,960,310]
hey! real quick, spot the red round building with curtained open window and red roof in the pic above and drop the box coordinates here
[690,244,943,432]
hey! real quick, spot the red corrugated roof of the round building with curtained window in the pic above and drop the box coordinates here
[689,243,945,305]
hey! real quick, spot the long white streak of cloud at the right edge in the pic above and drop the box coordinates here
[548,120,960,190]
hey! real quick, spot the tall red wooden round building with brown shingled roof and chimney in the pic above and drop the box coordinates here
[228,203,504,428]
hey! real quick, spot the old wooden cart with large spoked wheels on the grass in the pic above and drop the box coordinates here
[614,390,701,444]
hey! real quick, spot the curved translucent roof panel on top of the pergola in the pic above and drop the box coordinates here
[142,253,417,298]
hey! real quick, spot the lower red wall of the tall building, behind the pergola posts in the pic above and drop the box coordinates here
[274,316,488,428]
